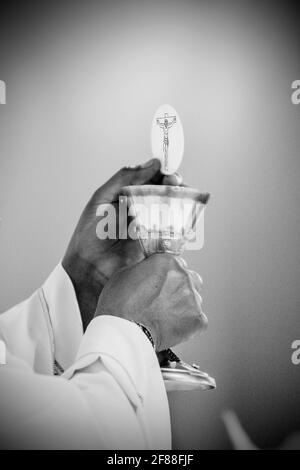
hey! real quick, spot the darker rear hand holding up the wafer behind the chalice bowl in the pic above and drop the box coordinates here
[62,159,181,329]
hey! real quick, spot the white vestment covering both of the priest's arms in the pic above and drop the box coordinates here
[0,265,171,449]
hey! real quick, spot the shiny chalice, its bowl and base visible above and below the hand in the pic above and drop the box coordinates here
[121,185,216,391]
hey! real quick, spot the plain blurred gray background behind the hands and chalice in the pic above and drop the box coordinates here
[0,0,300,448]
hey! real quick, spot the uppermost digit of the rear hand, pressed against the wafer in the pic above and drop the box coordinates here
[93,158,160,202]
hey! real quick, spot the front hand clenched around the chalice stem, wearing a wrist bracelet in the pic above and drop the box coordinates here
[95,254,207,351]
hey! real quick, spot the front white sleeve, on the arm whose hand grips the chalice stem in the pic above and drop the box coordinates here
[0,316,170,449]
